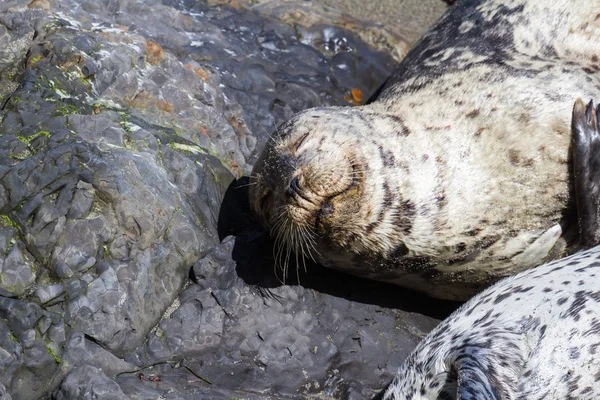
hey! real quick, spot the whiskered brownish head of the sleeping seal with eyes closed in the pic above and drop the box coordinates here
[250,108,412,272]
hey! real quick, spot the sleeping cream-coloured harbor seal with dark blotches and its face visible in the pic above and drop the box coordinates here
[249,0,600,300]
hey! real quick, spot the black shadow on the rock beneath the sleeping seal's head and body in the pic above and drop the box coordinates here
[218,177,461,319]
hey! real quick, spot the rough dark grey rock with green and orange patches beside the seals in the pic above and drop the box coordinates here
[0,0,452,399]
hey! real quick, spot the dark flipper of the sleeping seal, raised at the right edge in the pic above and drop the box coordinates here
[572,99,600,247]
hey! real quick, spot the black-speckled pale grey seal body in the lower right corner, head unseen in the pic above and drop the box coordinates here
[383,247,600,400]
